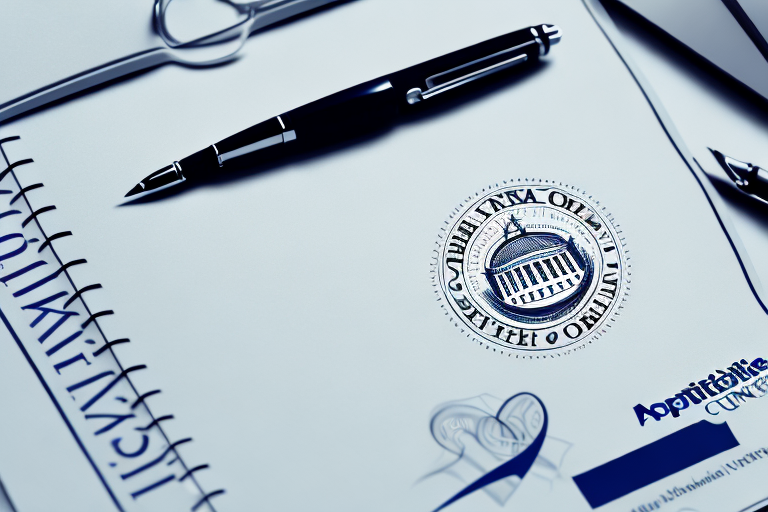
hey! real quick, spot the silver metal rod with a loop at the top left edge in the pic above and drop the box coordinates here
[0,0,339,122]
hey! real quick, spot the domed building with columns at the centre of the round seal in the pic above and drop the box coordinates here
[485,215,594,321]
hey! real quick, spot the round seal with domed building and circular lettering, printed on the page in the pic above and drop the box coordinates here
[436,180,630,357]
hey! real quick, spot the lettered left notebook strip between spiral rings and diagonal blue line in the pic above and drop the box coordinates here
[0,136,216,510]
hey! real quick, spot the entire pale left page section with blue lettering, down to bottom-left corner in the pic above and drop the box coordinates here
[0,136,218,510]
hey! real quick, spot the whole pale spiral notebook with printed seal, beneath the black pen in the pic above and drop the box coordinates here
[0,0,768,512]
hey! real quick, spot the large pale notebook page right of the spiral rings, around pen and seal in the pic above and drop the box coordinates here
[4,0,766,510]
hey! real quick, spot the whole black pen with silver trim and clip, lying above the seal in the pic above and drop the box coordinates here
[125,24,562,199]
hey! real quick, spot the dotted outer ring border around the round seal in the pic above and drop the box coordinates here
[430,178,632,359]
